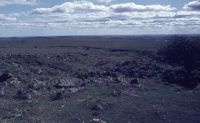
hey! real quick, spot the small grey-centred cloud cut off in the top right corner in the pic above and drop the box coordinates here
[183,0,200,11]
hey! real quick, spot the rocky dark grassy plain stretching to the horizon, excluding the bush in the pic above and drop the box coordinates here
[0,36,200,123]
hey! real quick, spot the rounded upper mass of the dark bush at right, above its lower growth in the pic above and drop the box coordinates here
[159,37,200,71]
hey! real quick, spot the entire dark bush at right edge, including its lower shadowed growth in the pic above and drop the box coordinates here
[158,37,200,88]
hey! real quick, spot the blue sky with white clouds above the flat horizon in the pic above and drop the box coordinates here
[0,0,200,37]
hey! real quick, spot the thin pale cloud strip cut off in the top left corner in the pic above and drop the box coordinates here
[0,0,38,6]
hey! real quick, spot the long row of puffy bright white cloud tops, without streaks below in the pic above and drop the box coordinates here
[32,1,176,14]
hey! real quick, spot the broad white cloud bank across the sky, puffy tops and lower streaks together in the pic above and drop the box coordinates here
[0,1,200,32]
